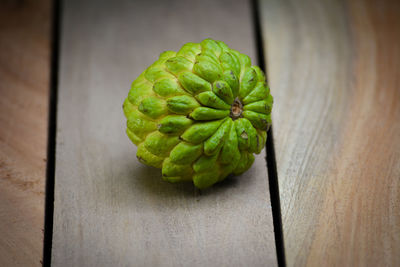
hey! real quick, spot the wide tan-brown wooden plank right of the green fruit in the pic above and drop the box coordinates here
[261,0,400,266]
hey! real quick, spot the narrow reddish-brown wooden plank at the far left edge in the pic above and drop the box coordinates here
[0,0,50,266]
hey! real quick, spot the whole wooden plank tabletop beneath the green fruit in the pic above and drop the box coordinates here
[0,0,400,266]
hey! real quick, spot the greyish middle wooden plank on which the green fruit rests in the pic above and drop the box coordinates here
[52,0,276,266]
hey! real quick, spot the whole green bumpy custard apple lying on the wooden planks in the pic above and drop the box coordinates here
[123,39,273,188]
